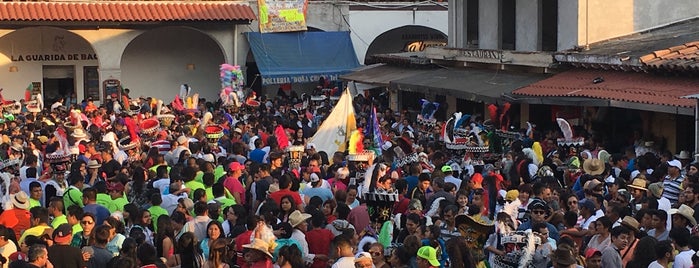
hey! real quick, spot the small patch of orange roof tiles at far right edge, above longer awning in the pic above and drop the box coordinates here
[641,41,699,71]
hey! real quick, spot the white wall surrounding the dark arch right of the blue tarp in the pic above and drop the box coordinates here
[349,10,449,63]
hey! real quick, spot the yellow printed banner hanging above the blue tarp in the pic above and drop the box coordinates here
[257,0,308,33]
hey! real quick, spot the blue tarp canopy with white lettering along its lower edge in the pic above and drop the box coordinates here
[245,32,359,85]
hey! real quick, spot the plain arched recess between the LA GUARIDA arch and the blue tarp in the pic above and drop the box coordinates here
[121,27,224,103]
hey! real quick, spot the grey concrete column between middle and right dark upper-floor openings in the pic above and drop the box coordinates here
[515,0,542,51]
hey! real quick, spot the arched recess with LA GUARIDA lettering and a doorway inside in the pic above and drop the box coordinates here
[0,26,99,107]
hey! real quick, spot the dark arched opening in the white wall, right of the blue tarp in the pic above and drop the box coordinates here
[364,25,447,65]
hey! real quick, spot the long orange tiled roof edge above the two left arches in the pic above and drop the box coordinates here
[0,1,256,22]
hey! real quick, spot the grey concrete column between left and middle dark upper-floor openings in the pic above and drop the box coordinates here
[478,0,502,49]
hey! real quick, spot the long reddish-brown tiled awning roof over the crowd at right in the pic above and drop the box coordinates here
[512,69,699,108]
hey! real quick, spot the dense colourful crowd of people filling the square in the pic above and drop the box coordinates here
[0,86,699,268]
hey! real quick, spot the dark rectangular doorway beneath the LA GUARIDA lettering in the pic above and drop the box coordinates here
[43,65,77,107]
